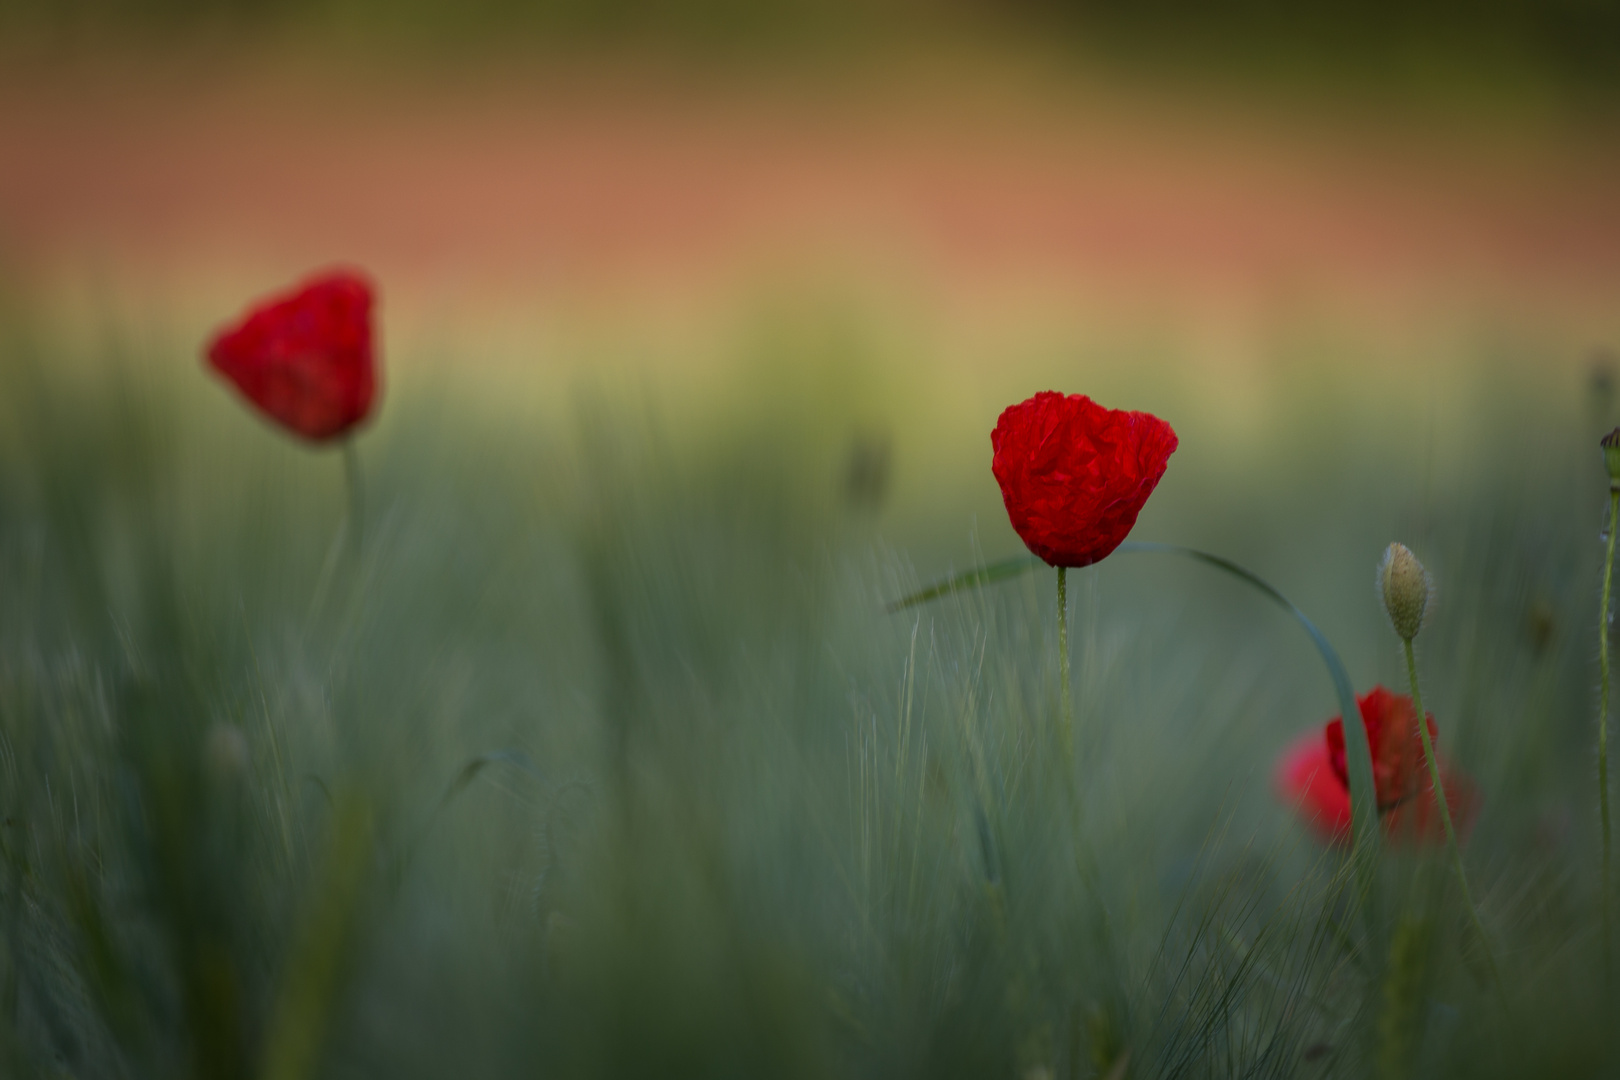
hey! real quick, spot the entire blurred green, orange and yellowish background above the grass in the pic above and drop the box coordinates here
[9,0,1620,414]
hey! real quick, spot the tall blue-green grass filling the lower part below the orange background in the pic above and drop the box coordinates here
[0,297,1617,1078]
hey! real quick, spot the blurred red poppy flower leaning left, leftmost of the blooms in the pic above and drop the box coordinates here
[207,270,377,442]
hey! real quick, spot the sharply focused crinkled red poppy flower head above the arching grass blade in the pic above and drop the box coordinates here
[990,390,1176,567]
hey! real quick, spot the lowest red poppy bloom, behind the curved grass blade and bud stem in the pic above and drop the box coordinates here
[1277,687,1479,844]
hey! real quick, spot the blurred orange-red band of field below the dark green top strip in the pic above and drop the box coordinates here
[0,53,1620,330]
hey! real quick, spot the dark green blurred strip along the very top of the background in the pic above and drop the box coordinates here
[9,0,1620,102]
